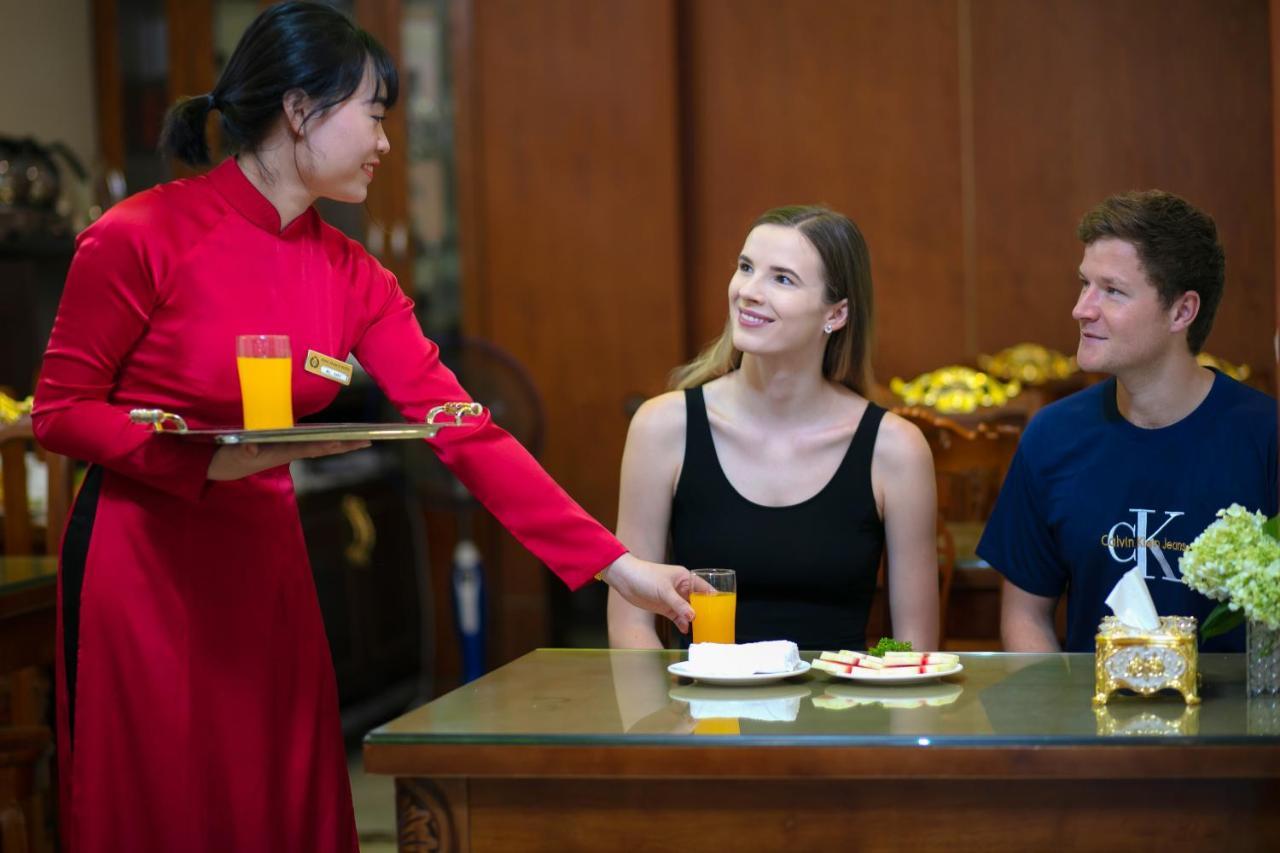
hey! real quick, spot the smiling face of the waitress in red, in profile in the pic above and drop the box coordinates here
[294,65,392,204]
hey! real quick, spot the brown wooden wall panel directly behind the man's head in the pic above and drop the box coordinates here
[972,0,1275,370]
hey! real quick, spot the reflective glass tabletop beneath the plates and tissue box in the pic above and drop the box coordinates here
[366,649,1280,747]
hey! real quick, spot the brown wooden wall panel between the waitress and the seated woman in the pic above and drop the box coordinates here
[454,0,684,650]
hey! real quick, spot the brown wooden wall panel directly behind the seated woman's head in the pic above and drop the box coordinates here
[681,0,963,382]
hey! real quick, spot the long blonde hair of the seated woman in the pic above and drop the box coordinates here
[667,206,874,396]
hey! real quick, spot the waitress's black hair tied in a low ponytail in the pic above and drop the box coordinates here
[160,0,399,165]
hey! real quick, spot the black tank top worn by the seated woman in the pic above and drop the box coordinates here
[671,388,884,649]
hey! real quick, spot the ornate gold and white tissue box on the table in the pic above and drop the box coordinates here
[1093,616,1199,704]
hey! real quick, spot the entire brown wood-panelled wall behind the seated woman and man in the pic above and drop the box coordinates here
[453,0,1277,660]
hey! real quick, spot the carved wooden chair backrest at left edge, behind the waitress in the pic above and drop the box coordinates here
[0,415,73,556]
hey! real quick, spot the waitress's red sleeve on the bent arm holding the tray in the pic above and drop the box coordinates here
[31,215,215,500]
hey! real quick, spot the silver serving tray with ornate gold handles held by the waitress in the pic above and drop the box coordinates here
[129,402,484,444]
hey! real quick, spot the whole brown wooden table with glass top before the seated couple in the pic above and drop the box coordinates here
[365,649,1280,853]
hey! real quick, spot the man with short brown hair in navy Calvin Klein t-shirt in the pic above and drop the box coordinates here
[978,191,1276,652]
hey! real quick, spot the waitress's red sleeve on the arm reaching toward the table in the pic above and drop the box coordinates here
[355,264,626,589]
